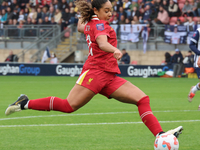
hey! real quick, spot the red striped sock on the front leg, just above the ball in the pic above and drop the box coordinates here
[137,96,163,136]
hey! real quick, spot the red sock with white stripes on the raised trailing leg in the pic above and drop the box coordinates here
[28,97,74,113]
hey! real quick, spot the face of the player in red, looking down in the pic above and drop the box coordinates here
[94,1,112,22]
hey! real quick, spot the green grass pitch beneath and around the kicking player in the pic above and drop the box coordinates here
[0,76,200,150]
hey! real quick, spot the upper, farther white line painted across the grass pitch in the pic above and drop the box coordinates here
[0,110,198,121]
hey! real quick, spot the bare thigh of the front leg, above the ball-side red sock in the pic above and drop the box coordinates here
[110,82,146,104]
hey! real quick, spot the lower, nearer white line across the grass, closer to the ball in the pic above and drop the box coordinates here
[0,120,200,128]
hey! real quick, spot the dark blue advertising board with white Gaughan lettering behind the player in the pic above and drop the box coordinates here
[0,63,172,78]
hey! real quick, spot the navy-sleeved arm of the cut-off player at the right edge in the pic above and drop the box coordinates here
[189,31,200,55]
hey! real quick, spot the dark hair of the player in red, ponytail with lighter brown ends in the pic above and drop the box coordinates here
[75,0,109,23]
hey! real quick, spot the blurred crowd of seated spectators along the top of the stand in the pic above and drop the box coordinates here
[0,0,200,30]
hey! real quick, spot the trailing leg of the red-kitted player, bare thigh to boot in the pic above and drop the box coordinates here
[5,84,95,115]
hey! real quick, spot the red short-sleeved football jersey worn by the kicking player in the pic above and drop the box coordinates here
[83,16,121,74]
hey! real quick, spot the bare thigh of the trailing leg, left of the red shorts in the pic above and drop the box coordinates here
[67,84,95,110]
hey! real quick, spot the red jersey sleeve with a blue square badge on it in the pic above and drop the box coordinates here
[94,21,111,39]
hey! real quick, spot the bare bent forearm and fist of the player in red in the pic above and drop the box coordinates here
[96,35,122,60]
